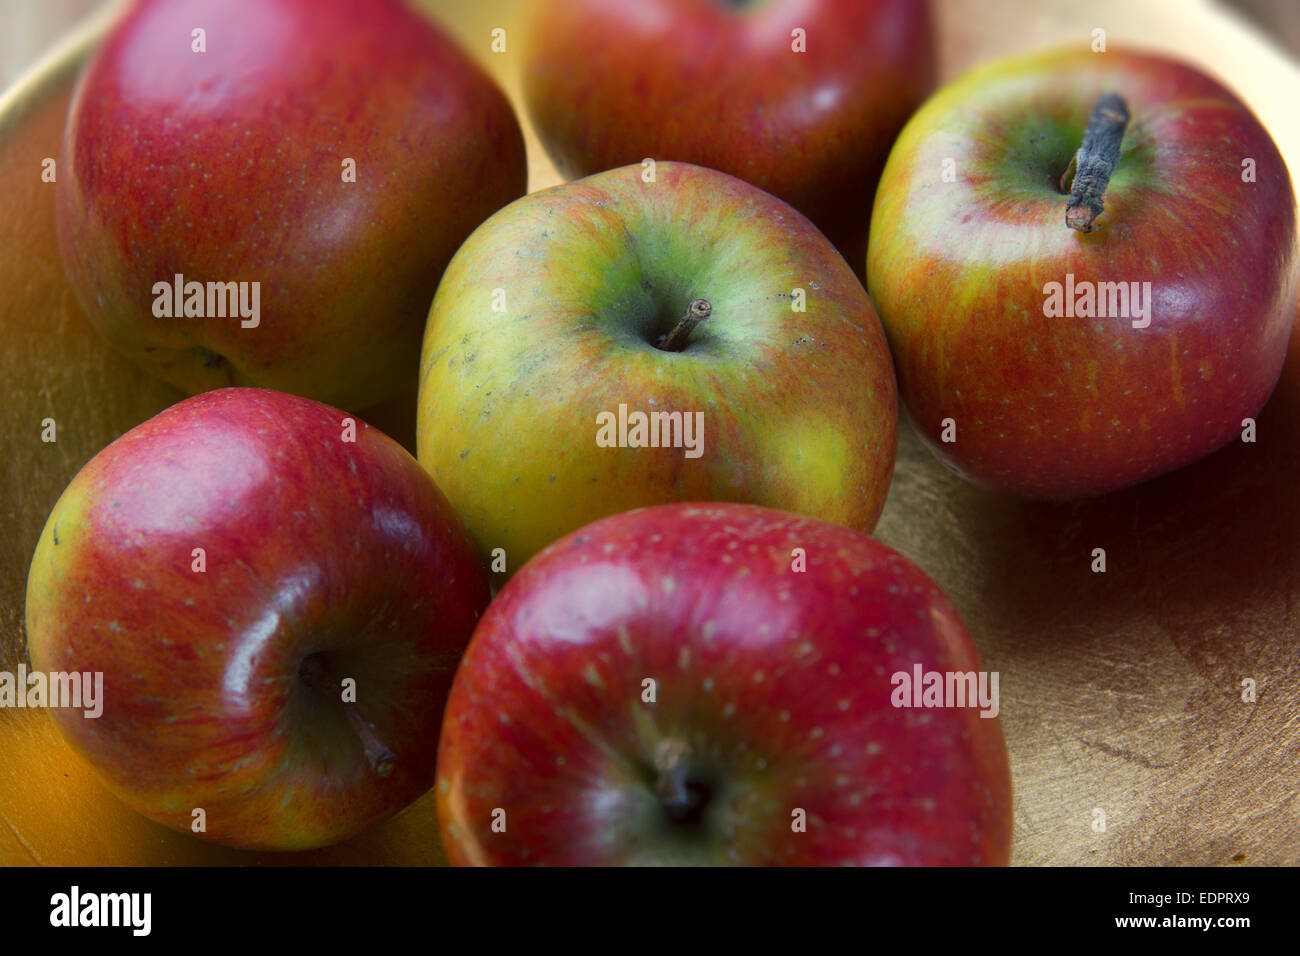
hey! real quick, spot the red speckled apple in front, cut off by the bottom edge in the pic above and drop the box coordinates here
[437,503,1011,866]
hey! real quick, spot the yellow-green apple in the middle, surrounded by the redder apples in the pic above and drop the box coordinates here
[416,163,897,580]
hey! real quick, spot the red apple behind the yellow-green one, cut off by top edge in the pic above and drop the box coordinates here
[524,0,935,269]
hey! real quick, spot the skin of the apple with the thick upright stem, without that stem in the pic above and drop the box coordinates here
[867,51,1300,499]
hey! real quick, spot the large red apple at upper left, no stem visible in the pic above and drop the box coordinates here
[56,0,527,410]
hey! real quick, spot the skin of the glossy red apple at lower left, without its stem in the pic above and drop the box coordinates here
[26,388,489,849]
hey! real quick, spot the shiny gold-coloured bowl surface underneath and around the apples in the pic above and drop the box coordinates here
[0,0,1300,865]
